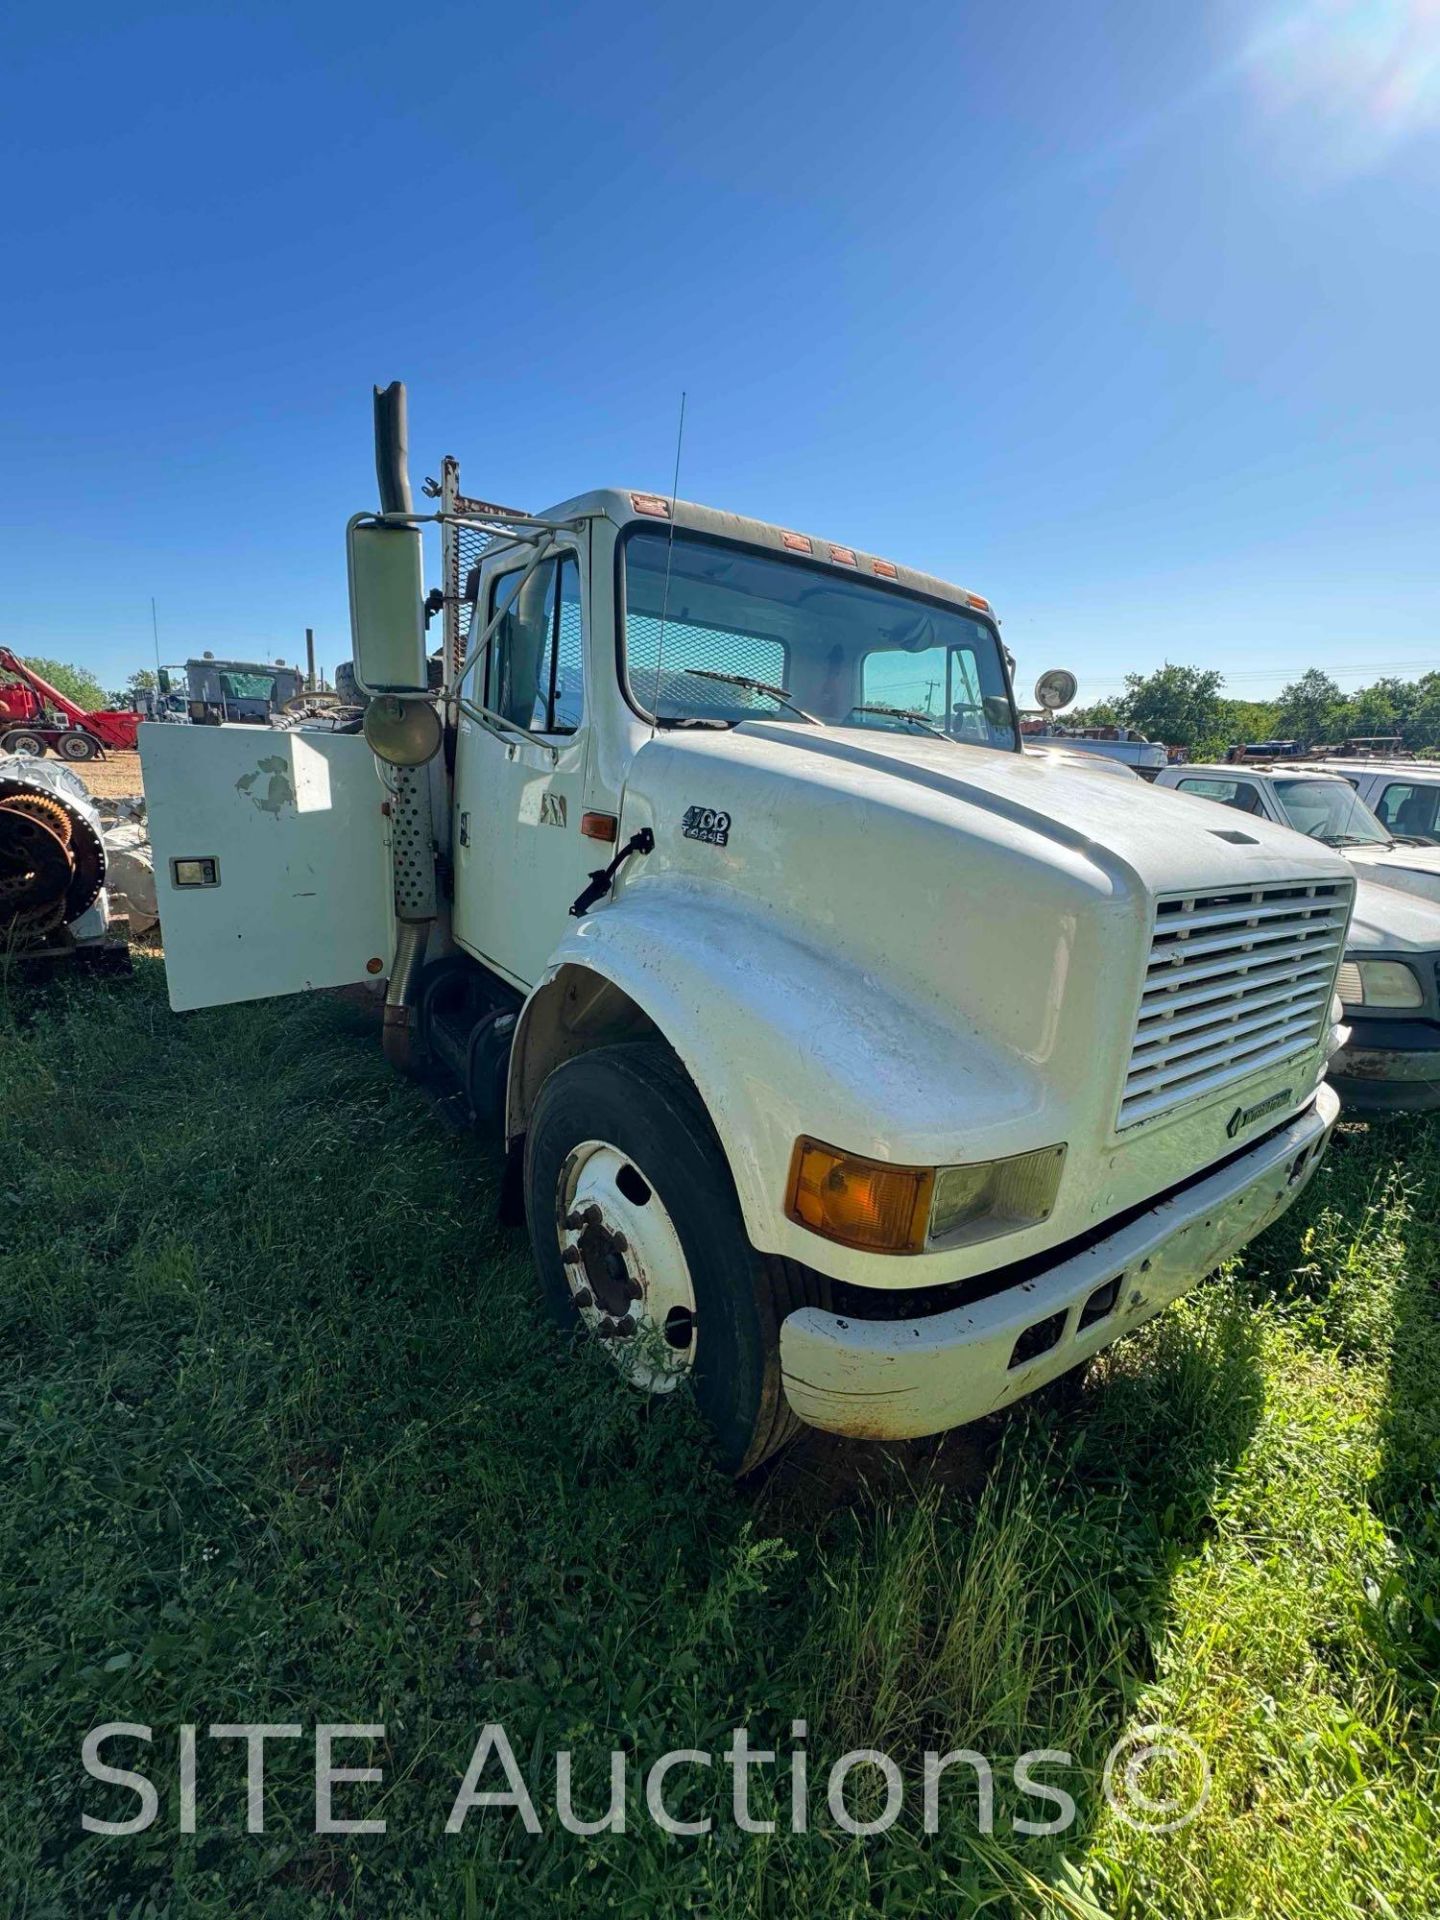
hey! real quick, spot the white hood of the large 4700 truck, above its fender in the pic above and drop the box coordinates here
[622,722,1354,1113]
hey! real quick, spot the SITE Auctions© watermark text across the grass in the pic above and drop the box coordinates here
[81,1720,1210,1837]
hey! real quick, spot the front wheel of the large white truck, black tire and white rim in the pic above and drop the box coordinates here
[524,1043,828,1473]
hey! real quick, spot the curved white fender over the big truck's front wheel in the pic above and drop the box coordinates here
[507,876,1054,1286]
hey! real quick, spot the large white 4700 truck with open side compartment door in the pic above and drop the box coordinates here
[142,388,1354,1471]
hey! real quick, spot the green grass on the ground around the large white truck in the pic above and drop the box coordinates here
[0,960,1440,1920]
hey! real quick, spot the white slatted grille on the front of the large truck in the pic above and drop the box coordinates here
[1117,881,1354,1127]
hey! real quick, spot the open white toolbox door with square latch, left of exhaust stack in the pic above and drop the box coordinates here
[140,724,394,1012]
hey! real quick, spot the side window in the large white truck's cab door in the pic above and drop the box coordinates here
[484,555,584,733]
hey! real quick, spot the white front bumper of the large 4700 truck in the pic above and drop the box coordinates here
[780,1085,1340,1440]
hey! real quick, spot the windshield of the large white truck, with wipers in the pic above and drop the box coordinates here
[624,532,1016,749]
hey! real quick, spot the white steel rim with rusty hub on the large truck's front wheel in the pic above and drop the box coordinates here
[555,1140,697,1394]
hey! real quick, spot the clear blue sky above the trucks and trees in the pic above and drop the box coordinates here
[0,0,1440,699]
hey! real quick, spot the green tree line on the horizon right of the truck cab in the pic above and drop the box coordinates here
[1064,660,1440,760]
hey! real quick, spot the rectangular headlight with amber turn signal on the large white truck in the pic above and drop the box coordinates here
[785,1139,1066,1254]
